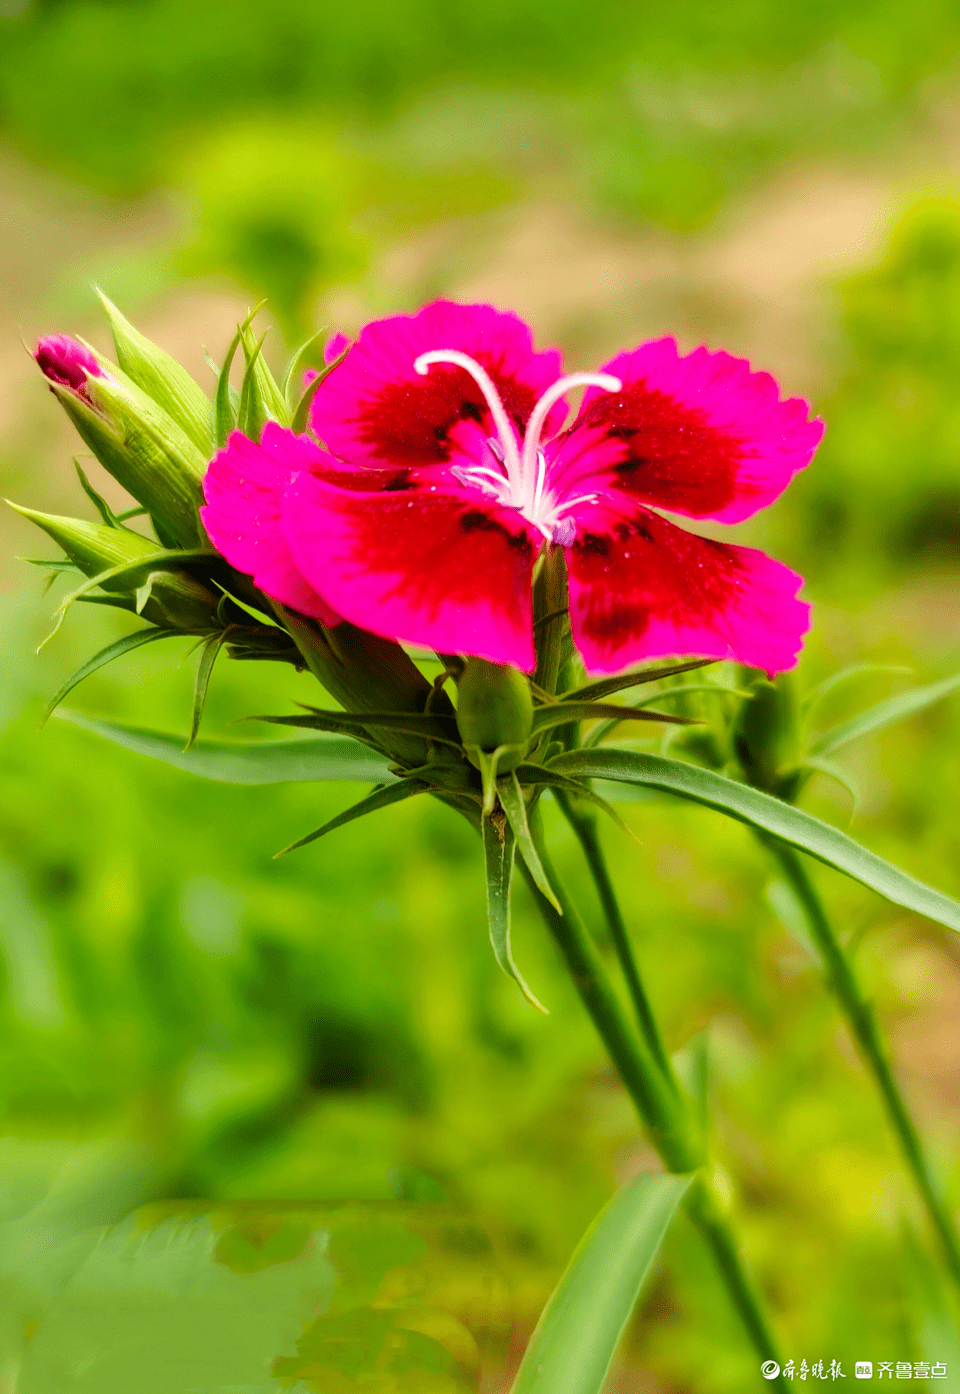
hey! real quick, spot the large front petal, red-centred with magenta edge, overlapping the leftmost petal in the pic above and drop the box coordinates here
[284,471,539,672]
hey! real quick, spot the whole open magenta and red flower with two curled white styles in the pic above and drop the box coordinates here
[202,301,823,673]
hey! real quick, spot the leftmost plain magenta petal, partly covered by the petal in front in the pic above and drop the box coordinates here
[201,422,341,626]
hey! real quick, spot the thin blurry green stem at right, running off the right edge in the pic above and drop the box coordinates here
[761,838,960,1282]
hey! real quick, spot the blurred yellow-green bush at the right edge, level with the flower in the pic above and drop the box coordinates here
[797,197,960,587]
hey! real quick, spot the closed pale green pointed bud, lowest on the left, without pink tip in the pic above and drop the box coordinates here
[10,503,220,630]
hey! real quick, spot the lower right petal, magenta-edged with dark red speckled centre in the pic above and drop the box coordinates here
[567,506,810,673]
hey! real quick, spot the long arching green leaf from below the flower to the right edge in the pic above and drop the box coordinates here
[550,749,960,931]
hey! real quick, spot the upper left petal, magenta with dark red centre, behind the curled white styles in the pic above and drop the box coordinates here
[311,300,566,466]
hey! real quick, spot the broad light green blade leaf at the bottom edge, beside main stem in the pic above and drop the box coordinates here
[511,1177,690,1394]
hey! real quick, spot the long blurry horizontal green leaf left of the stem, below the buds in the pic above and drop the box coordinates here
[54,707,396,785]
